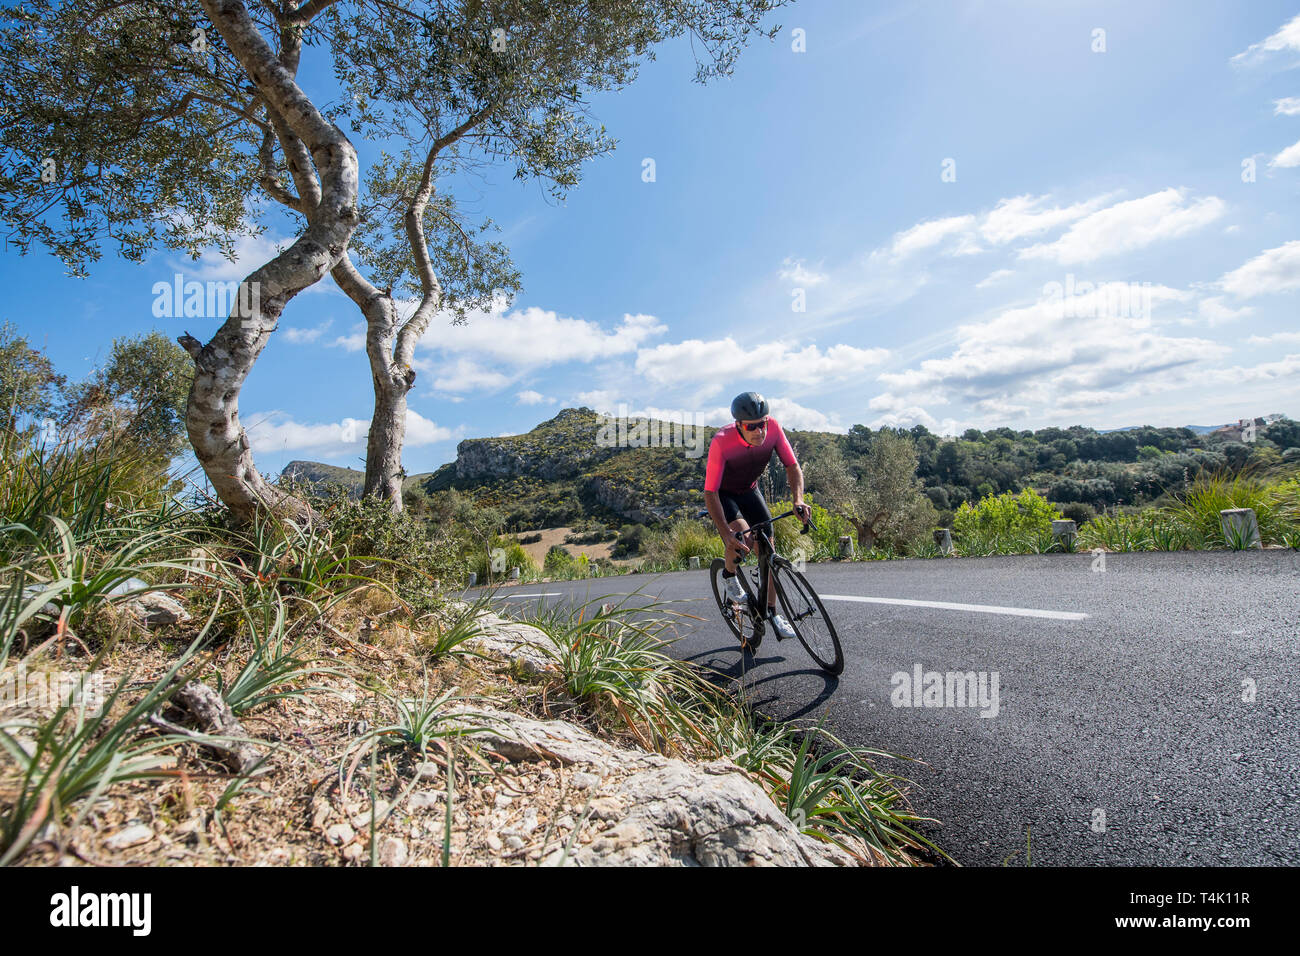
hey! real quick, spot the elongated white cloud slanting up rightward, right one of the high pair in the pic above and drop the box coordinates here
[1021,189,1227,265]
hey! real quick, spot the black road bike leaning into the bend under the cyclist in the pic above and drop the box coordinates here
[701,511,844,674]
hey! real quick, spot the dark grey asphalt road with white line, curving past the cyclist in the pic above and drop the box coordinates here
[473,550,1300,866]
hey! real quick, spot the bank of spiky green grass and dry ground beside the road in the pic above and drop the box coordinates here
[0,385,943,865]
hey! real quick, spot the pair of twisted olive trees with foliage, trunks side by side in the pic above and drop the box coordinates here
[0,0,781,518]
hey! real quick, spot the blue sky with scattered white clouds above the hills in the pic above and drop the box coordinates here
[0,0,1300,472]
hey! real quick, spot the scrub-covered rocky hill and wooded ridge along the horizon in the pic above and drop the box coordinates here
[283,407,1300,531]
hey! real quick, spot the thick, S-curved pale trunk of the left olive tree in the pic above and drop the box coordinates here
[177,0,358,520]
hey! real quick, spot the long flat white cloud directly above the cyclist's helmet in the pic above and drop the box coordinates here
[636,336,889,385]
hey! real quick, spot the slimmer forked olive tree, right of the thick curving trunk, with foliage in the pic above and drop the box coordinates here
[280,0,776,509]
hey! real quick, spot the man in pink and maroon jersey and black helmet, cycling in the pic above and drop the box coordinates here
[705,392,813,639]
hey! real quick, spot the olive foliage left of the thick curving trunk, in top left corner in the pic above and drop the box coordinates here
[0,0,260,276]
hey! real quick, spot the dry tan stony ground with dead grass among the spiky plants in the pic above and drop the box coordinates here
[0,598,621,866]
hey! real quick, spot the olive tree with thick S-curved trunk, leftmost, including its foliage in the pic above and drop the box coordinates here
[0,0,358,519]
